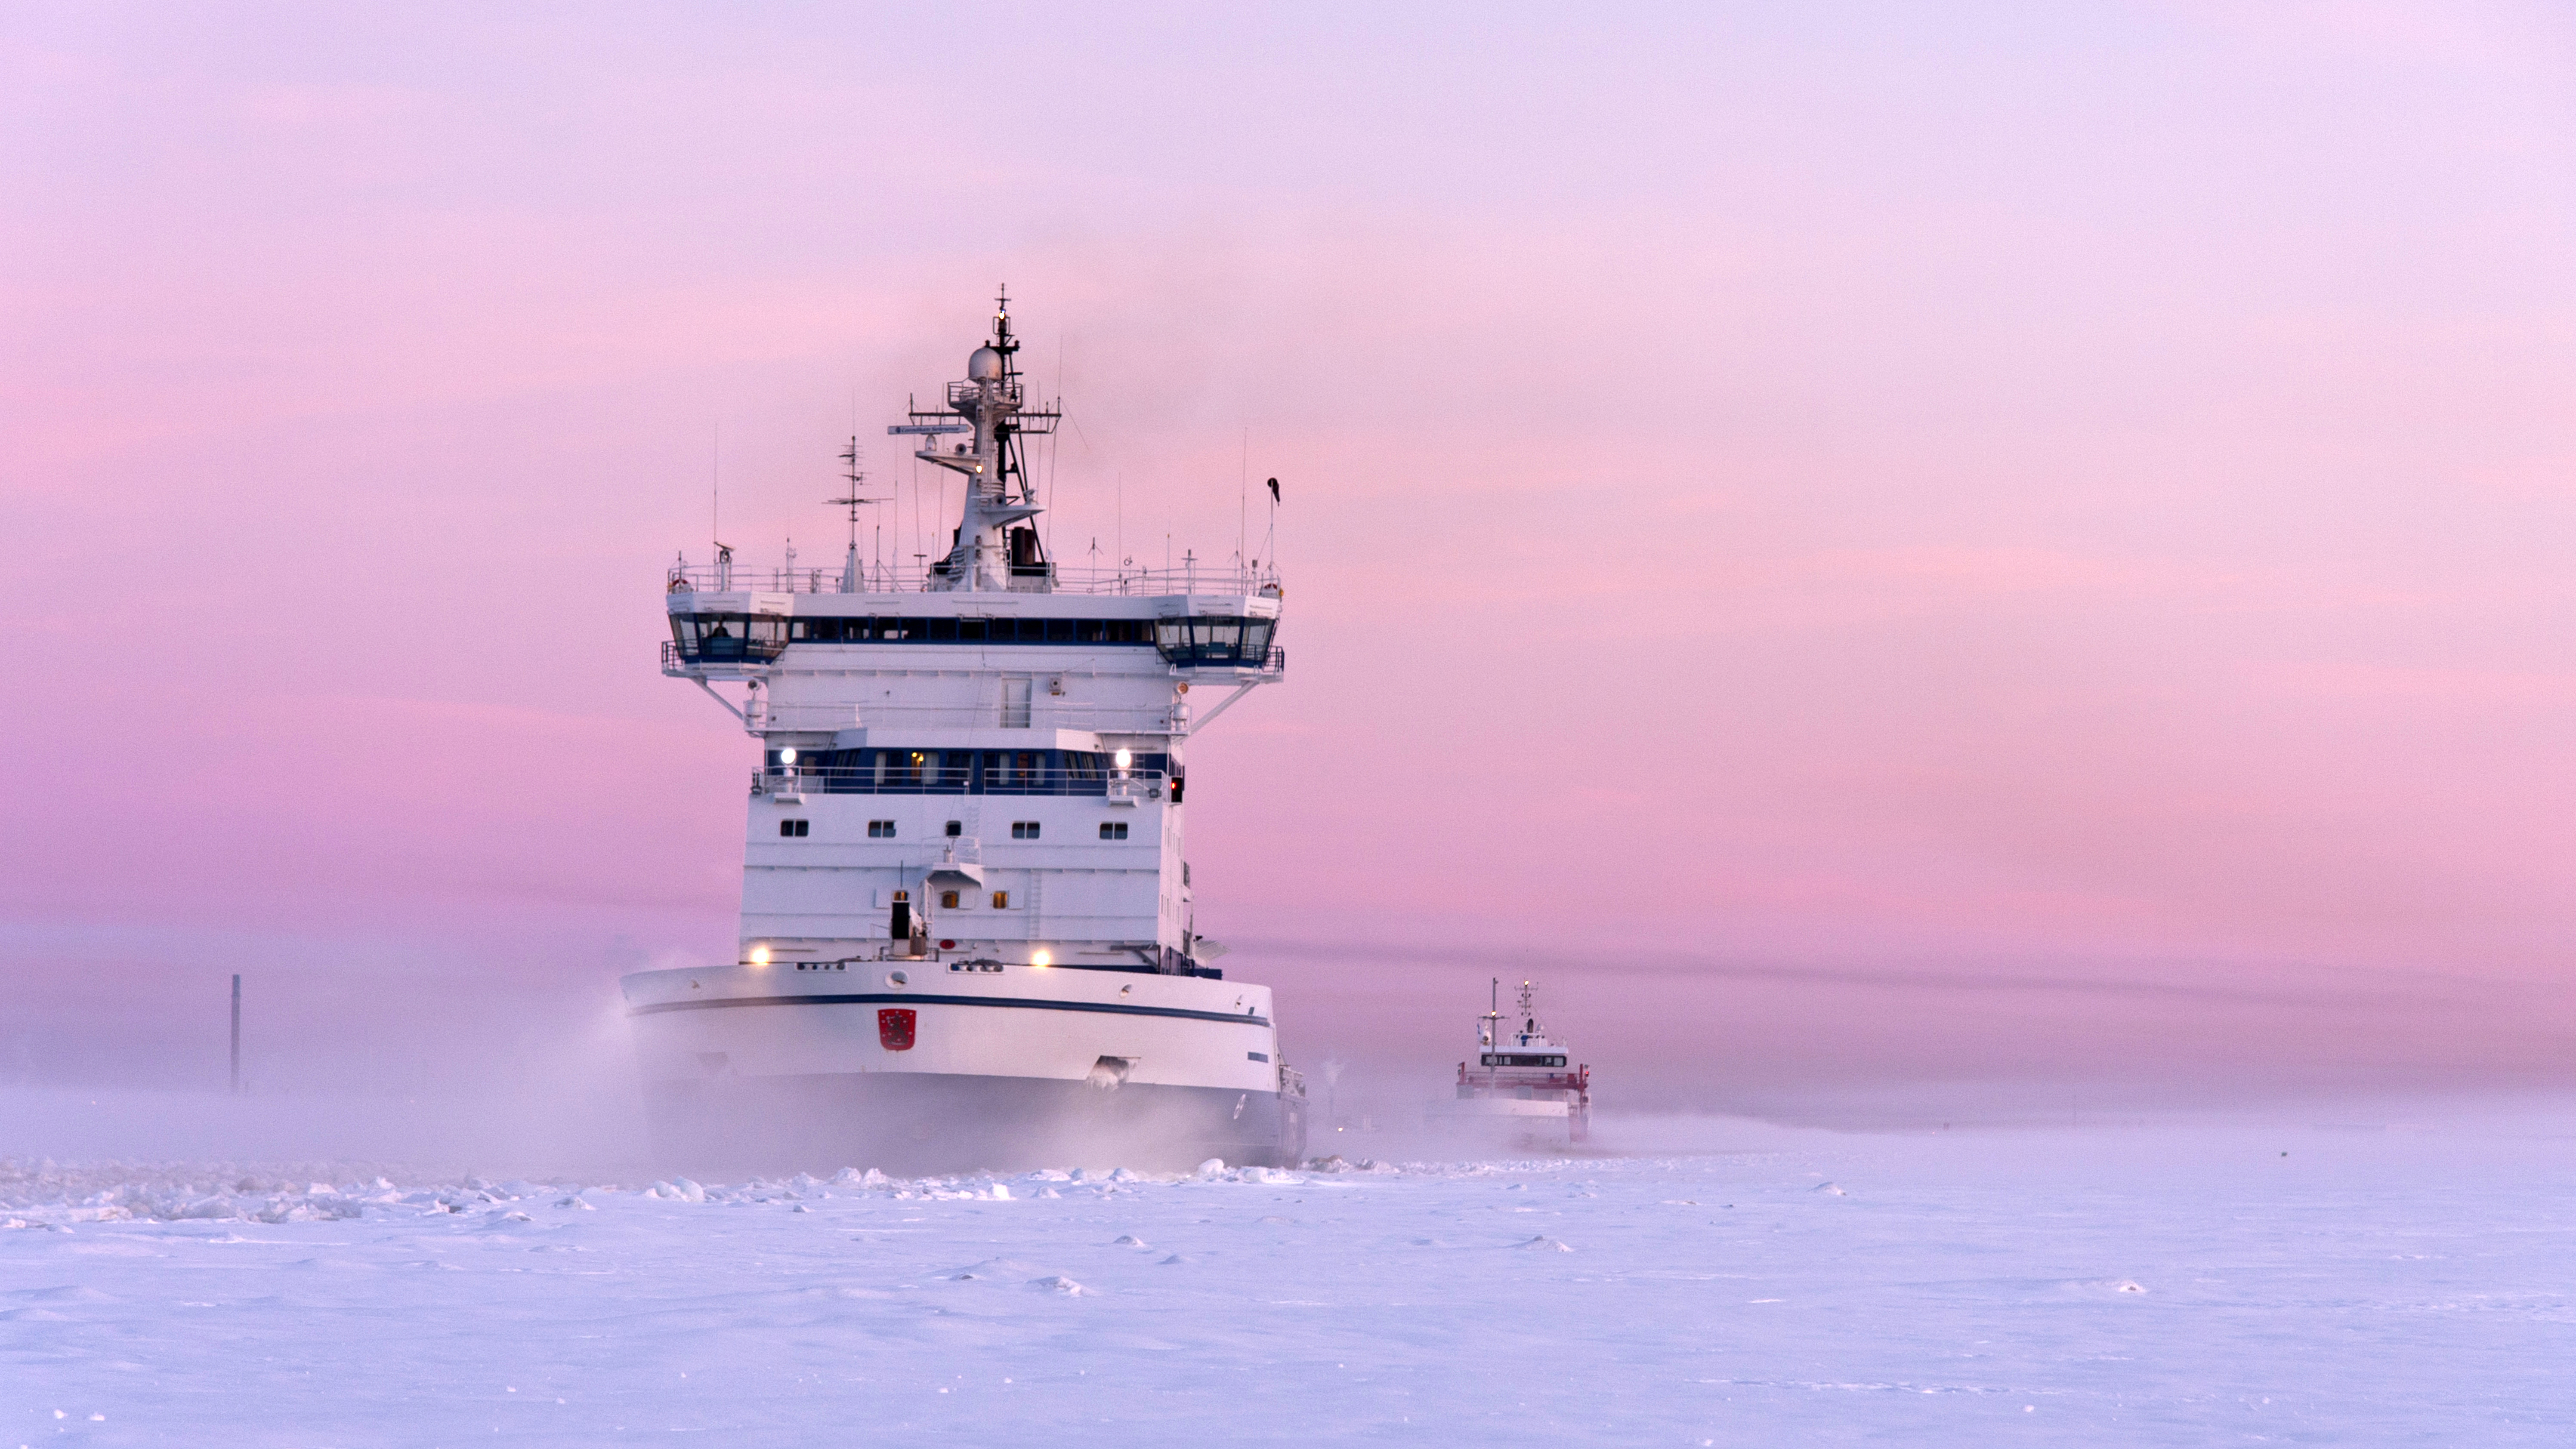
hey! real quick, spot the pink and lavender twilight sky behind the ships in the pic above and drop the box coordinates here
[0,3,2576,1107]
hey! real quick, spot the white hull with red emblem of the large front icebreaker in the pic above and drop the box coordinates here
[626,960,1306,1174]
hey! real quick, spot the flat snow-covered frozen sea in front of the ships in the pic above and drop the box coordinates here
[0,1107,2576,1449]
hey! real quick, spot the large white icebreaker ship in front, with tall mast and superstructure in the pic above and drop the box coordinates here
[624,293,1306,1171]
